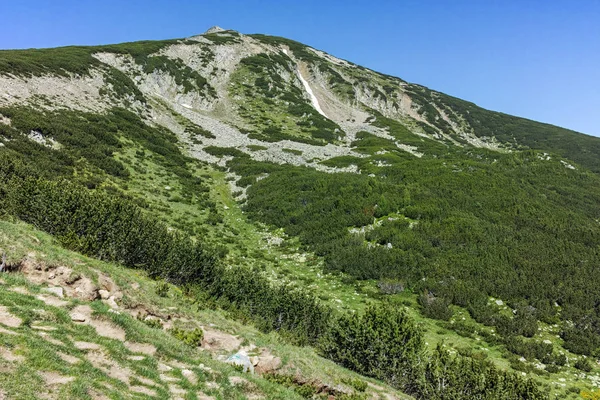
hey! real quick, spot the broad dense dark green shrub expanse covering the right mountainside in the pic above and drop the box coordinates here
[230,148,600,355]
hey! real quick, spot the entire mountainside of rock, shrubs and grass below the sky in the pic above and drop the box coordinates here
[0,27,600,399]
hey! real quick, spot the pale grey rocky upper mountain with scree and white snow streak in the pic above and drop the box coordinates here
[0,29,598,169]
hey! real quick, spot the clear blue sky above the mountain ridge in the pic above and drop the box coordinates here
[0,0,600,136]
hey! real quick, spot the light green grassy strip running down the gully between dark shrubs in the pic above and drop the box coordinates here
[98,134,598,396]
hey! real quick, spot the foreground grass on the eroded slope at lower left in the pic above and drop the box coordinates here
[0,220,410,399]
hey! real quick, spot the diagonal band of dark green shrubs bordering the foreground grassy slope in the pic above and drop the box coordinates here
[0,159,543,399]
